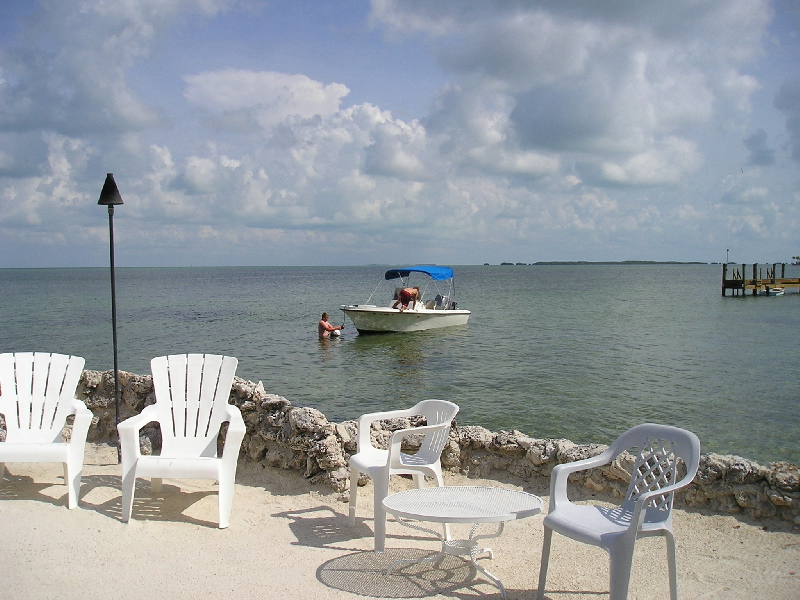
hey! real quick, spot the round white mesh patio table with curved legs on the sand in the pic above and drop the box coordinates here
[383,486,542,598]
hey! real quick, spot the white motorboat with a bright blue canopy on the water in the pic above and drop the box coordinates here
[341,265,472,333]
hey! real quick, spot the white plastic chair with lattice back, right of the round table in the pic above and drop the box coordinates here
[537,423,700,600]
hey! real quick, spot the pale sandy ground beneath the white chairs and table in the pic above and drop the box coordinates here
[0,445,800,600]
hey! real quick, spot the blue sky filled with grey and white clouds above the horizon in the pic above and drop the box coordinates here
[0,0,800,268]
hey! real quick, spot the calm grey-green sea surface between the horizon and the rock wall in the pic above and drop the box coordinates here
[0,265,800,463]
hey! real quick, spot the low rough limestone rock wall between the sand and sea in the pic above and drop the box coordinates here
[10,371,800,526]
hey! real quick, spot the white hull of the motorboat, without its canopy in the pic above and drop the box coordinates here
[341,304,471,333]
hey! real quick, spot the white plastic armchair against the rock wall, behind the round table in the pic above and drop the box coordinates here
[349,400,458,552]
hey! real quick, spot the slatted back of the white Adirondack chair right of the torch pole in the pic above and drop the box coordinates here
[150,354,239,457]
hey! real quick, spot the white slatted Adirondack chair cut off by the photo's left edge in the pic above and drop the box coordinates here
[0,352,92,508]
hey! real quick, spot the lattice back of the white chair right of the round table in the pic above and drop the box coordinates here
[612,423,700,518]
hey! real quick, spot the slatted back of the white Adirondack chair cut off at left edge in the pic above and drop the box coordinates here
[0,352,85,443]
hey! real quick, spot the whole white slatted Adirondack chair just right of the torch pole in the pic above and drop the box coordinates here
[117,354,245,528]
